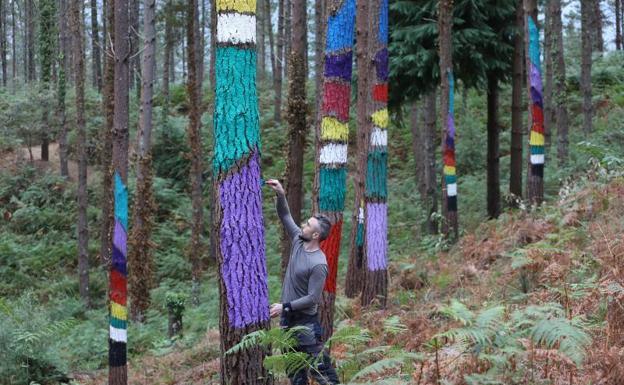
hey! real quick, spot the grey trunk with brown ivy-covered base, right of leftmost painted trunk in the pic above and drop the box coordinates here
[128,0,156,322]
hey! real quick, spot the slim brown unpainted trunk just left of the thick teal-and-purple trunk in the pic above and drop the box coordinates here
[186,0,204,305]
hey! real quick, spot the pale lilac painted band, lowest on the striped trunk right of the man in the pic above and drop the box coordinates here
[366,203,388,271]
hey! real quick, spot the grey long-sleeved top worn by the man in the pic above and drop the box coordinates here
[276,194,327,315]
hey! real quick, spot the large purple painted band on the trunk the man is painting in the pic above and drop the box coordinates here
[219,154,269,328]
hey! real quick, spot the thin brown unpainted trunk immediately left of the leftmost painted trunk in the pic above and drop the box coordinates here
[100,0,115,265]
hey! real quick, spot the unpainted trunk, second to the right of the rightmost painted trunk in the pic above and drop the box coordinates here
[581,1,593,135]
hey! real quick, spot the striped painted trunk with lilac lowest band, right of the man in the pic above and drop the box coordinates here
[356,0,389,308]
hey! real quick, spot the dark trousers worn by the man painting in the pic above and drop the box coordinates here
[280,312,340,385]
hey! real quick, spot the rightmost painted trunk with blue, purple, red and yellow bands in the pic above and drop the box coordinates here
[524,0,545,204]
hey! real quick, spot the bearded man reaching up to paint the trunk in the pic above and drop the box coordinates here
[266,179,340,385]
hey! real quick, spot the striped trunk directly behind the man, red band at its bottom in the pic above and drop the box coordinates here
[315,0,355,337]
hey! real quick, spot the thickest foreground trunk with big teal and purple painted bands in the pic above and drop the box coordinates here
[212,0,270,385]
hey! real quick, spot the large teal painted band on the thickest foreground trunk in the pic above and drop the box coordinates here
[212,47,260,174]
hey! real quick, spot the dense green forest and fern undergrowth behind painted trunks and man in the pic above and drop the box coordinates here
[0,0,624,385]
